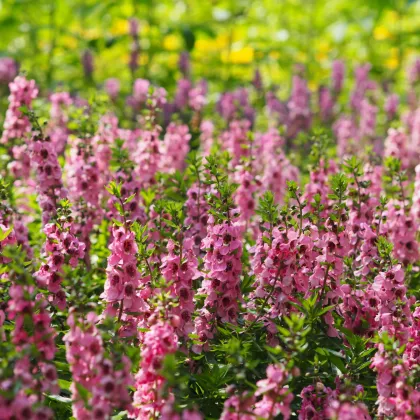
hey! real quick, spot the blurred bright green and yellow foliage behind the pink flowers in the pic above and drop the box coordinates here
[0,0,420,91]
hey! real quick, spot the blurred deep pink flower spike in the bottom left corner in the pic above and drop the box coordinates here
[0,274,59,419]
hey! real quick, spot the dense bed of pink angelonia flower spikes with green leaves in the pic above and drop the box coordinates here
[0,53,420,420]
